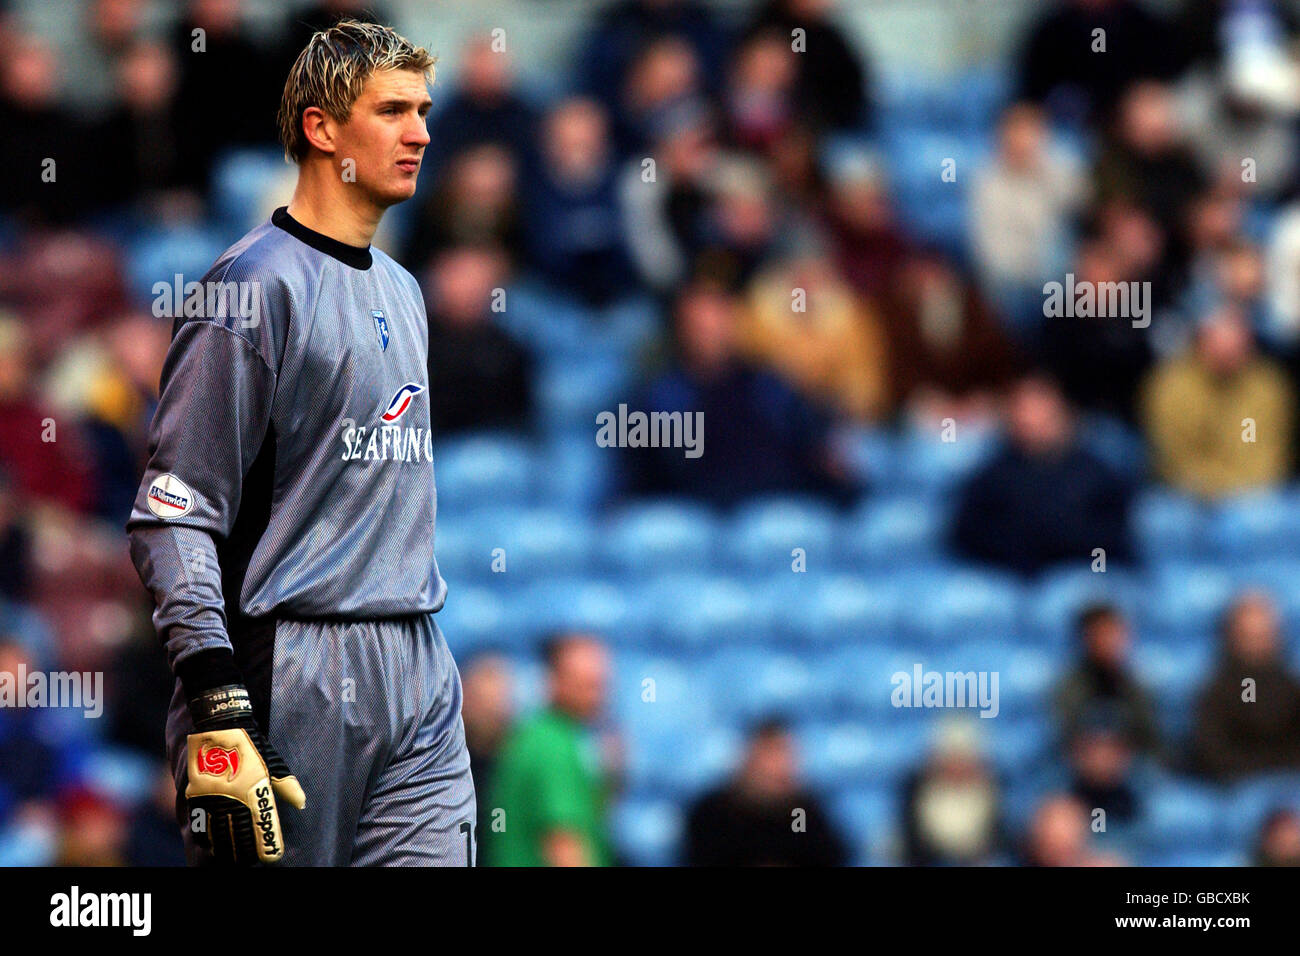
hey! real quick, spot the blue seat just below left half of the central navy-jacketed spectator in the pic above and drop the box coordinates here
[601,501,716,579]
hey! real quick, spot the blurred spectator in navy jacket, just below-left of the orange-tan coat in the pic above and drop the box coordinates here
[624,280,855,507]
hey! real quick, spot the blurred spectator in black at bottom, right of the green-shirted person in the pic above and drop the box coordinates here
[684,719,849,866]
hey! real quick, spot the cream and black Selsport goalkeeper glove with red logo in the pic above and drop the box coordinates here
[185,658,307,866]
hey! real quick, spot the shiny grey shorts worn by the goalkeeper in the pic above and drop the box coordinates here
[166,614,477,866]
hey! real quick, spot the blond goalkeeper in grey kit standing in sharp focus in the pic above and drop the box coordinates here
[126,21,475,866]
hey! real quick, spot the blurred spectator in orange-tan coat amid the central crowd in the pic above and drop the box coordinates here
[738,241,889,421]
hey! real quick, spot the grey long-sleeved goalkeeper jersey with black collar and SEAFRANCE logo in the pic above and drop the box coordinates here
[126,208,446,667]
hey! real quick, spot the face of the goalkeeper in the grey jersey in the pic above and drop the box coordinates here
[334,70,433,208]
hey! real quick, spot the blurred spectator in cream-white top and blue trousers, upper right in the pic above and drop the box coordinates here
[969,103,1086,329]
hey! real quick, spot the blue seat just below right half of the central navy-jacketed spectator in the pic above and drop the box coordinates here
[719,498,836,572]
